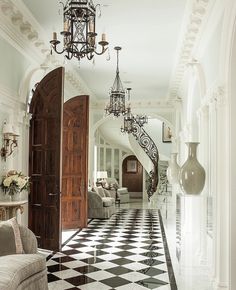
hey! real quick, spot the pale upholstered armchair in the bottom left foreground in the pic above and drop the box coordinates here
[0,223,48,290]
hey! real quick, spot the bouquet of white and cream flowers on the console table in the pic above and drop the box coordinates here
[1,170,30,195]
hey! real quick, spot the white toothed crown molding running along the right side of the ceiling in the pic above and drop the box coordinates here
[167,0,212,100]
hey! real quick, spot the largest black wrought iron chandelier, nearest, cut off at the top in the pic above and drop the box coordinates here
[50,0,108,60]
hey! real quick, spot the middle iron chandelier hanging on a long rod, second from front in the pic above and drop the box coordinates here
[105,46,126,117]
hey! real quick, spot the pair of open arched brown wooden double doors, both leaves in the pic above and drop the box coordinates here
[29,68,88,251]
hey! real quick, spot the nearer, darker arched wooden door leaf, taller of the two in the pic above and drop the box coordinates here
[29,68,64,251]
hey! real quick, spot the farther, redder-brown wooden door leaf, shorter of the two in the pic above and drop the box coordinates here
[61,96,89,229]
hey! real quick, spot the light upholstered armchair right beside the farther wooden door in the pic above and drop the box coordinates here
[88,187,116,219]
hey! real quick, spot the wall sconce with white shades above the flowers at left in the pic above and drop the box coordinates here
[1,121,19,161]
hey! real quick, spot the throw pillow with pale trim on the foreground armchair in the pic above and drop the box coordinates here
[0,218,23,256]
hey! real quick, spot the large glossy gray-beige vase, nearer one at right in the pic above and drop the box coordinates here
[179,142,206,195]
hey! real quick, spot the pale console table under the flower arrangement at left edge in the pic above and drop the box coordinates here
[0,199,28,221]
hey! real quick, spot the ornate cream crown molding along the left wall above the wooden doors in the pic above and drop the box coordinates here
[0,0,94,98]
